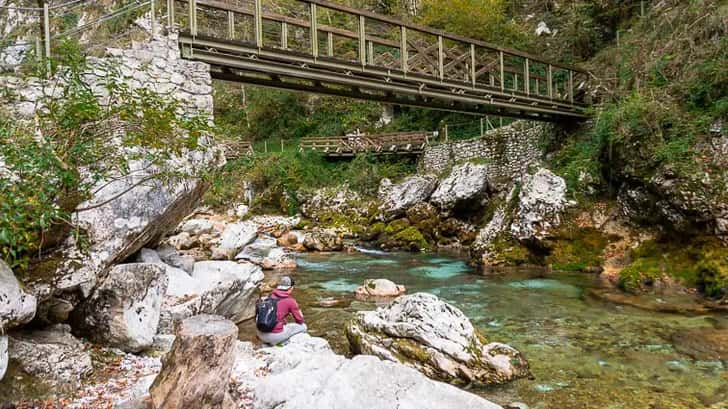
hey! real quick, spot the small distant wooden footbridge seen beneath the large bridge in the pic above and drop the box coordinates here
[299,132,434,157]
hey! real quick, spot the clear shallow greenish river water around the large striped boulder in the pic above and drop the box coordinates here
[280,254,728,409]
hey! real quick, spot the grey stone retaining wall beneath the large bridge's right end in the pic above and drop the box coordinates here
[420,121,553,183]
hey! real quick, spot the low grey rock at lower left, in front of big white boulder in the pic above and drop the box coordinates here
[8,324,93,390]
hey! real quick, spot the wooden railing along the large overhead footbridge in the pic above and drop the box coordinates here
[168,0,587,106]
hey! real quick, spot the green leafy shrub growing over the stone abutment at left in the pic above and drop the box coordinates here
[0,43,208,267]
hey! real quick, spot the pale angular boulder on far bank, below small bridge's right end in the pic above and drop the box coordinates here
[378,175,437,220]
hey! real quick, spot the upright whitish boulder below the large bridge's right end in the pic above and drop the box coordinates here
[510,168,568,241]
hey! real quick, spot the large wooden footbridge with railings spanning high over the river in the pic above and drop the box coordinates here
[172,0,587,120]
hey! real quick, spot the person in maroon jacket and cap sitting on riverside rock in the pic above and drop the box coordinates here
[256,276,308,345]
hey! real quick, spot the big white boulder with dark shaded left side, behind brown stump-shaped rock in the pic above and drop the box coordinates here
[73,263,168,352]
